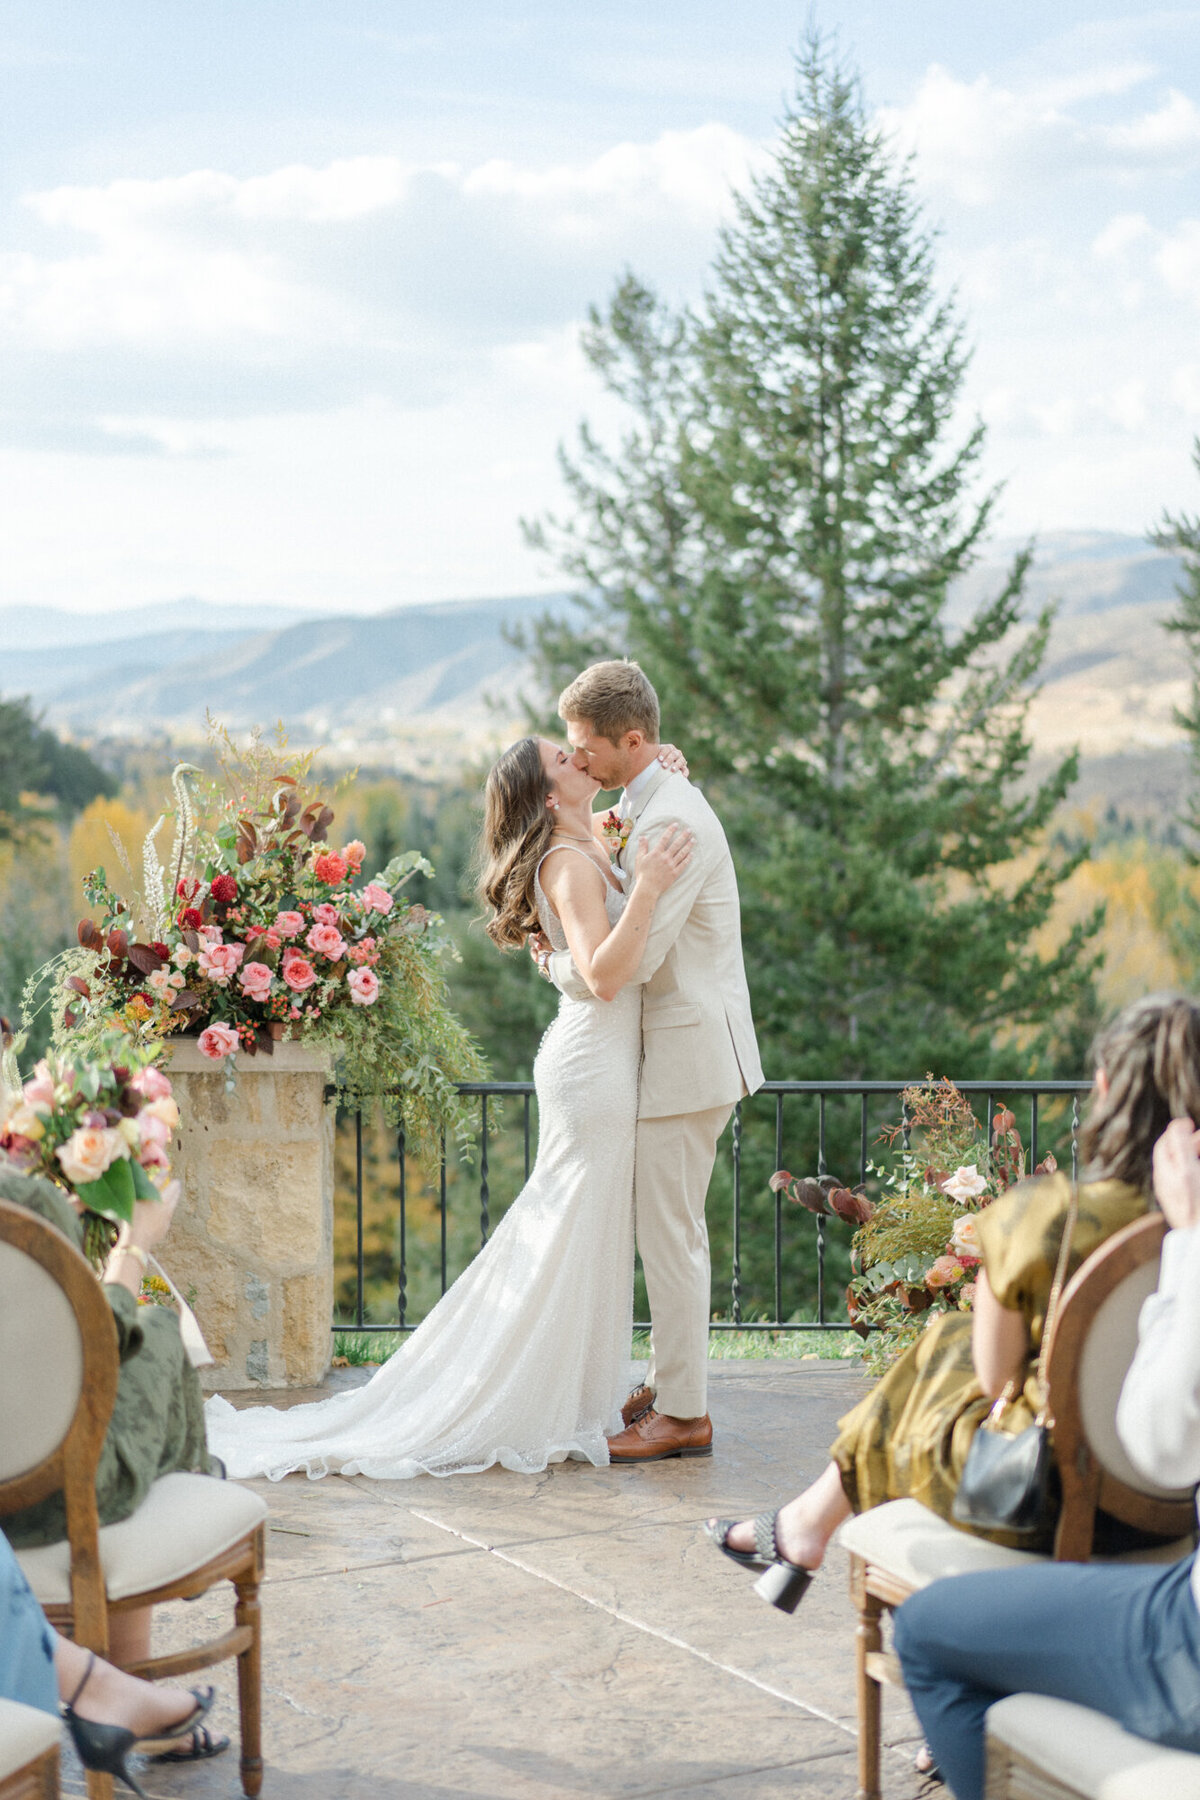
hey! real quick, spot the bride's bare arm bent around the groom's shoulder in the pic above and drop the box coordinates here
[542,824,693,1001]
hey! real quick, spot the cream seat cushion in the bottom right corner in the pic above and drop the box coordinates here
[988,1694,1200,1800]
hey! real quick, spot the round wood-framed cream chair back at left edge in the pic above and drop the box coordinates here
[0,1201,119,1656]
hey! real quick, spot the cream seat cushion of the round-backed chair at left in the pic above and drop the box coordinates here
[16,1474,266,1606]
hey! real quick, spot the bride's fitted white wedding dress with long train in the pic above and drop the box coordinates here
[205,846,642,1481]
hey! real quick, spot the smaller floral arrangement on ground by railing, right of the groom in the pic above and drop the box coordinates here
[770,1075,1058,1370]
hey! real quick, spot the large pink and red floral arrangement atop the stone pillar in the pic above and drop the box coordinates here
[25,734,484,1154]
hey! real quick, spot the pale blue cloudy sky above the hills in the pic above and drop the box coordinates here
[0,0,1200,610]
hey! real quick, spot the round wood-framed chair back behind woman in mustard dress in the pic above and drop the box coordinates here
[1047,1211,1195,1562]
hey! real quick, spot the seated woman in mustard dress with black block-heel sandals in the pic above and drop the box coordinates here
[705,995,1200,1611]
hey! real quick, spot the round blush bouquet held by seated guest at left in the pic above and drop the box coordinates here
[0,1031,180,1269]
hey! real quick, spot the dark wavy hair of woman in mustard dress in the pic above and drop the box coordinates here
[1079,994,1200,1193]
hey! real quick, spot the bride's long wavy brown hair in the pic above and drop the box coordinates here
[479,738,554,950]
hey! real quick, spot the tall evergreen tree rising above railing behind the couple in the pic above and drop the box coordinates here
[529,38,1097,1076]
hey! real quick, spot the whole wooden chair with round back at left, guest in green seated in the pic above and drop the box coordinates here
[0,1202,266,1800]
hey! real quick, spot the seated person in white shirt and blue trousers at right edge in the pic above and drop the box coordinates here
[894,1094,1200,1800]
